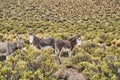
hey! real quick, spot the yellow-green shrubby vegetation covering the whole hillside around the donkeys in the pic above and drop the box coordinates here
[0,0,120,80]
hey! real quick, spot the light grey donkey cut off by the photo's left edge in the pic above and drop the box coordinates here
[0,39,25,59]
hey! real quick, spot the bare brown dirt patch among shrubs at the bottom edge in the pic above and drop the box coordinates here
[55,67,86,80]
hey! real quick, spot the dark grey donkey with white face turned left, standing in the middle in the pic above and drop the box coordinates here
[29,34,55,50]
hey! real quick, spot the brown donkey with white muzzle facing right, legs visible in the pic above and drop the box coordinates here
[55,35,81,64]
